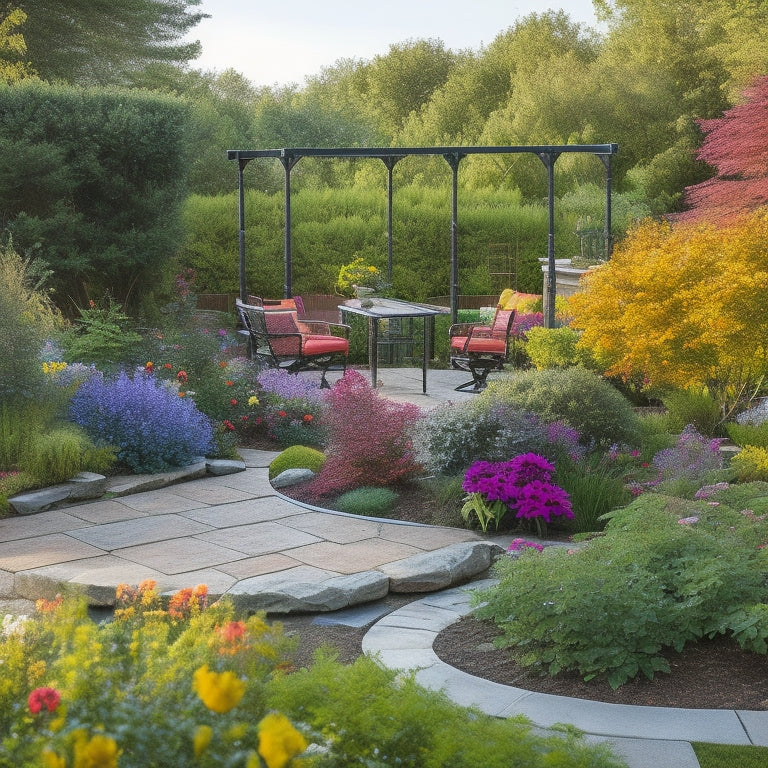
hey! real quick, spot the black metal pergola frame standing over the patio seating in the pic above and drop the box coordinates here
[227,144,619,327]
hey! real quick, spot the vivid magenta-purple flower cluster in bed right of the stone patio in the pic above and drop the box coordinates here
[462,453,573,523]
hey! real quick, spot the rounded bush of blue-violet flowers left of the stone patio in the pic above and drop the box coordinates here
[71,373,213,473]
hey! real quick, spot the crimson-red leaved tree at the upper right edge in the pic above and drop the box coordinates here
[678,76,768,224]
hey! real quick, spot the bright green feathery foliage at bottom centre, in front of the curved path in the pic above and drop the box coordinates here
[266,654,621,768]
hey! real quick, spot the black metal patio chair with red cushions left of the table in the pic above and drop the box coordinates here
[235,297,349,388]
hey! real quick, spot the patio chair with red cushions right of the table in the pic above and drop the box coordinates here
[448,309,515,392]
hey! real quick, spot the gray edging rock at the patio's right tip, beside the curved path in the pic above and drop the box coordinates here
[381,541,500,592]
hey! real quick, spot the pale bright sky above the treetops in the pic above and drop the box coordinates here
[191,0,598,86]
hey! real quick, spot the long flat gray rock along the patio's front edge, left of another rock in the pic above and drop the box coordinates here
[229,571,389,613]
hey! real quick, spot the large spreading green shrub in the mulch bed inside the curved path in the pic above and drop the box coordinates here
[477,494,768,688]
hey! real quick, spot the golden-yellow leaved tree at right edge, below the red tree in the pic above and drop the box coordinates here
[570,209,768,411]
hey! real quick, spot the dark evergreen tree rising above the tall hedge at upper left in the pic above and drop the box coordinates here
[19,0,207,85]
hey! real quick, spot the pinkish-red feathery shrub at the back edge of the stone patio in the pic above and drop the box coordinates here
[308,370,422,497]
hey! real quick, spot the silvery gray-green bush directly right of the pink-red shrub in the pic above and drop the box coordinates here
[411,398,547,475]
